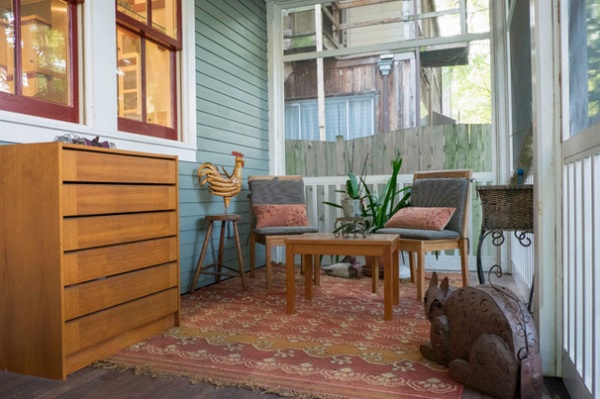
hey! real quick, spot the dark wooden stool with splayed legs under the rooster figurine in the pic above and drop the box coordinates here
[190,214,246,293]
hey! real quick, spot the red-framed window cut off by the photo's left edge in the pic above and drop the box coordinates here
[0,0,83,123]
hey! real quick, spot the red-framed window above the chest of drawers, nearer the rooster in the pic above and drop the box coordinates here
[116,0,181,140]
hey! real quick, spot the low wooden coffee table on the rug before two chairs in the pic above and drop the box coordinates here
[285,233,400,320]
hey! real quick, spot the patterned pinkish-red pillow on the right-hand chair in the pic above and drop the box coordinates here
[385,206,456,230]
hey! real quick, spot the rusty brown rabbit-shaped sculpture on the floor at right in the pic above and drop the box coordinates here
[420,273,543,399]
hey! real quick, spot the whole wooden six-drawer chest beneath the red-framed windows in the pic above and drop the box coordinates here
[0,143,180,379]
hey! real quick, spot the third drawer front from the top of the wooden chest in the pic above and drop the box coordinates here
[63,211,177,251]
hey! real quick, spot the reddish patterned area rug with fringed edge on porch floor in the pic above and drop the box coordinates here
[96,265,463,399]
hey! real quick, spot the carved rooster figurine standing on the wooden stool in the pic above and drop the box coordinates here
[198,151,244,212]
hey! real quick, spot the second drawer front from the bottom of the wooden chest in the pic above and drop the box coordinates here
[64,263,179,320]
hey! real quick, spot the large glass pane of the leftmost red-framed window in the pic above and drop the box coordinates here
[21,0,71,105]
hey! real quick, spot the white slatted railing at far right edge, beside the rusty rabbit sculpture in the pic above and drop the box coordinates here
[564,139,600,398]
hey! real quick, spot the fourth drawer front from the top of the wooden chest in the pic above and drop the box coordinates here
[63,237,179,286]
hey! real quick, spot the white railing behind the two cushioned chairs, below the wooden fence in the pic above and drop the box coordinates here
[304,173,533,276]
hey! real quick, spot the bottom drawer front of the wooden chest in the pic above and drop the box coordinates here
[63,288,179,355]
